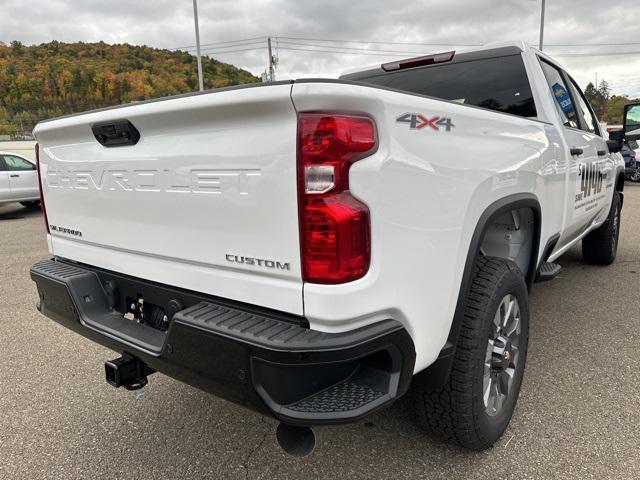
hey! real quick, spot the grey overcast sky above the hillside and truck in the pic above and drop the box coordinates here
[0,0,640,96]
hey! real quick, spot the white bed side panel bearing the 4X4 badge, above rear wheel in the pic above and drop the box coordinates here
[292,82,566,371]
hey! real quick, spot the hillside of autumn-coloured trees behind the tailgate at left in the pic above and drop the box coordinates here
[0,41,258,134]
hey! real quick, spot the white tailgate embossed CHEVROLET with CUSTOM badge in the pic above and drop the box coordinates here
[34,84,303,314]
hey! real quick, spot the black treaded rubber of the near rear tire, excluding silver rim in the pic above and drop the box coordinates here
[413,257,529,450]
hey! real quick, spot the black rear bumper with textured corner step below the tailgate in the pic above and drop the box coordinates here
[31,259,415,425]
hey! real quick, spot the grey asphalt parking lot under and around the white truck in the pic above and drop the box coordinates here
[0,184,640,480]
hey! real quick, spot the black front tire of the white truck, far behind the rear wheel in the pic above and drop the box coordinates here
[582,192,620,265]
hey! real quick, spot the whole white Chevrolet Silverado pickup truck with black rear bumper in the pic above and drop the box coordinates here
[31,42,624,453]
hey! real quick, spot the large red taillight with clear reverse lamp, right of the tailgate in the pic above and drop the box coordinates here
[298,112,377,284]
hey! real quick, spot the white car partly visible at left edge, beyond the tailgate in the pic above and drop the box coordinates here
[0,152,40,208]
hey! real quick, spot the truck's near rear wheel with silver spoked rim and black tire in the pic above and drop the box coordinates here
[413,257,529,450]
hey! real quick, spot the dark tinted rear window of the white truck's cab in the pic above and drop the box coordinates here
[357,55,537,117]
